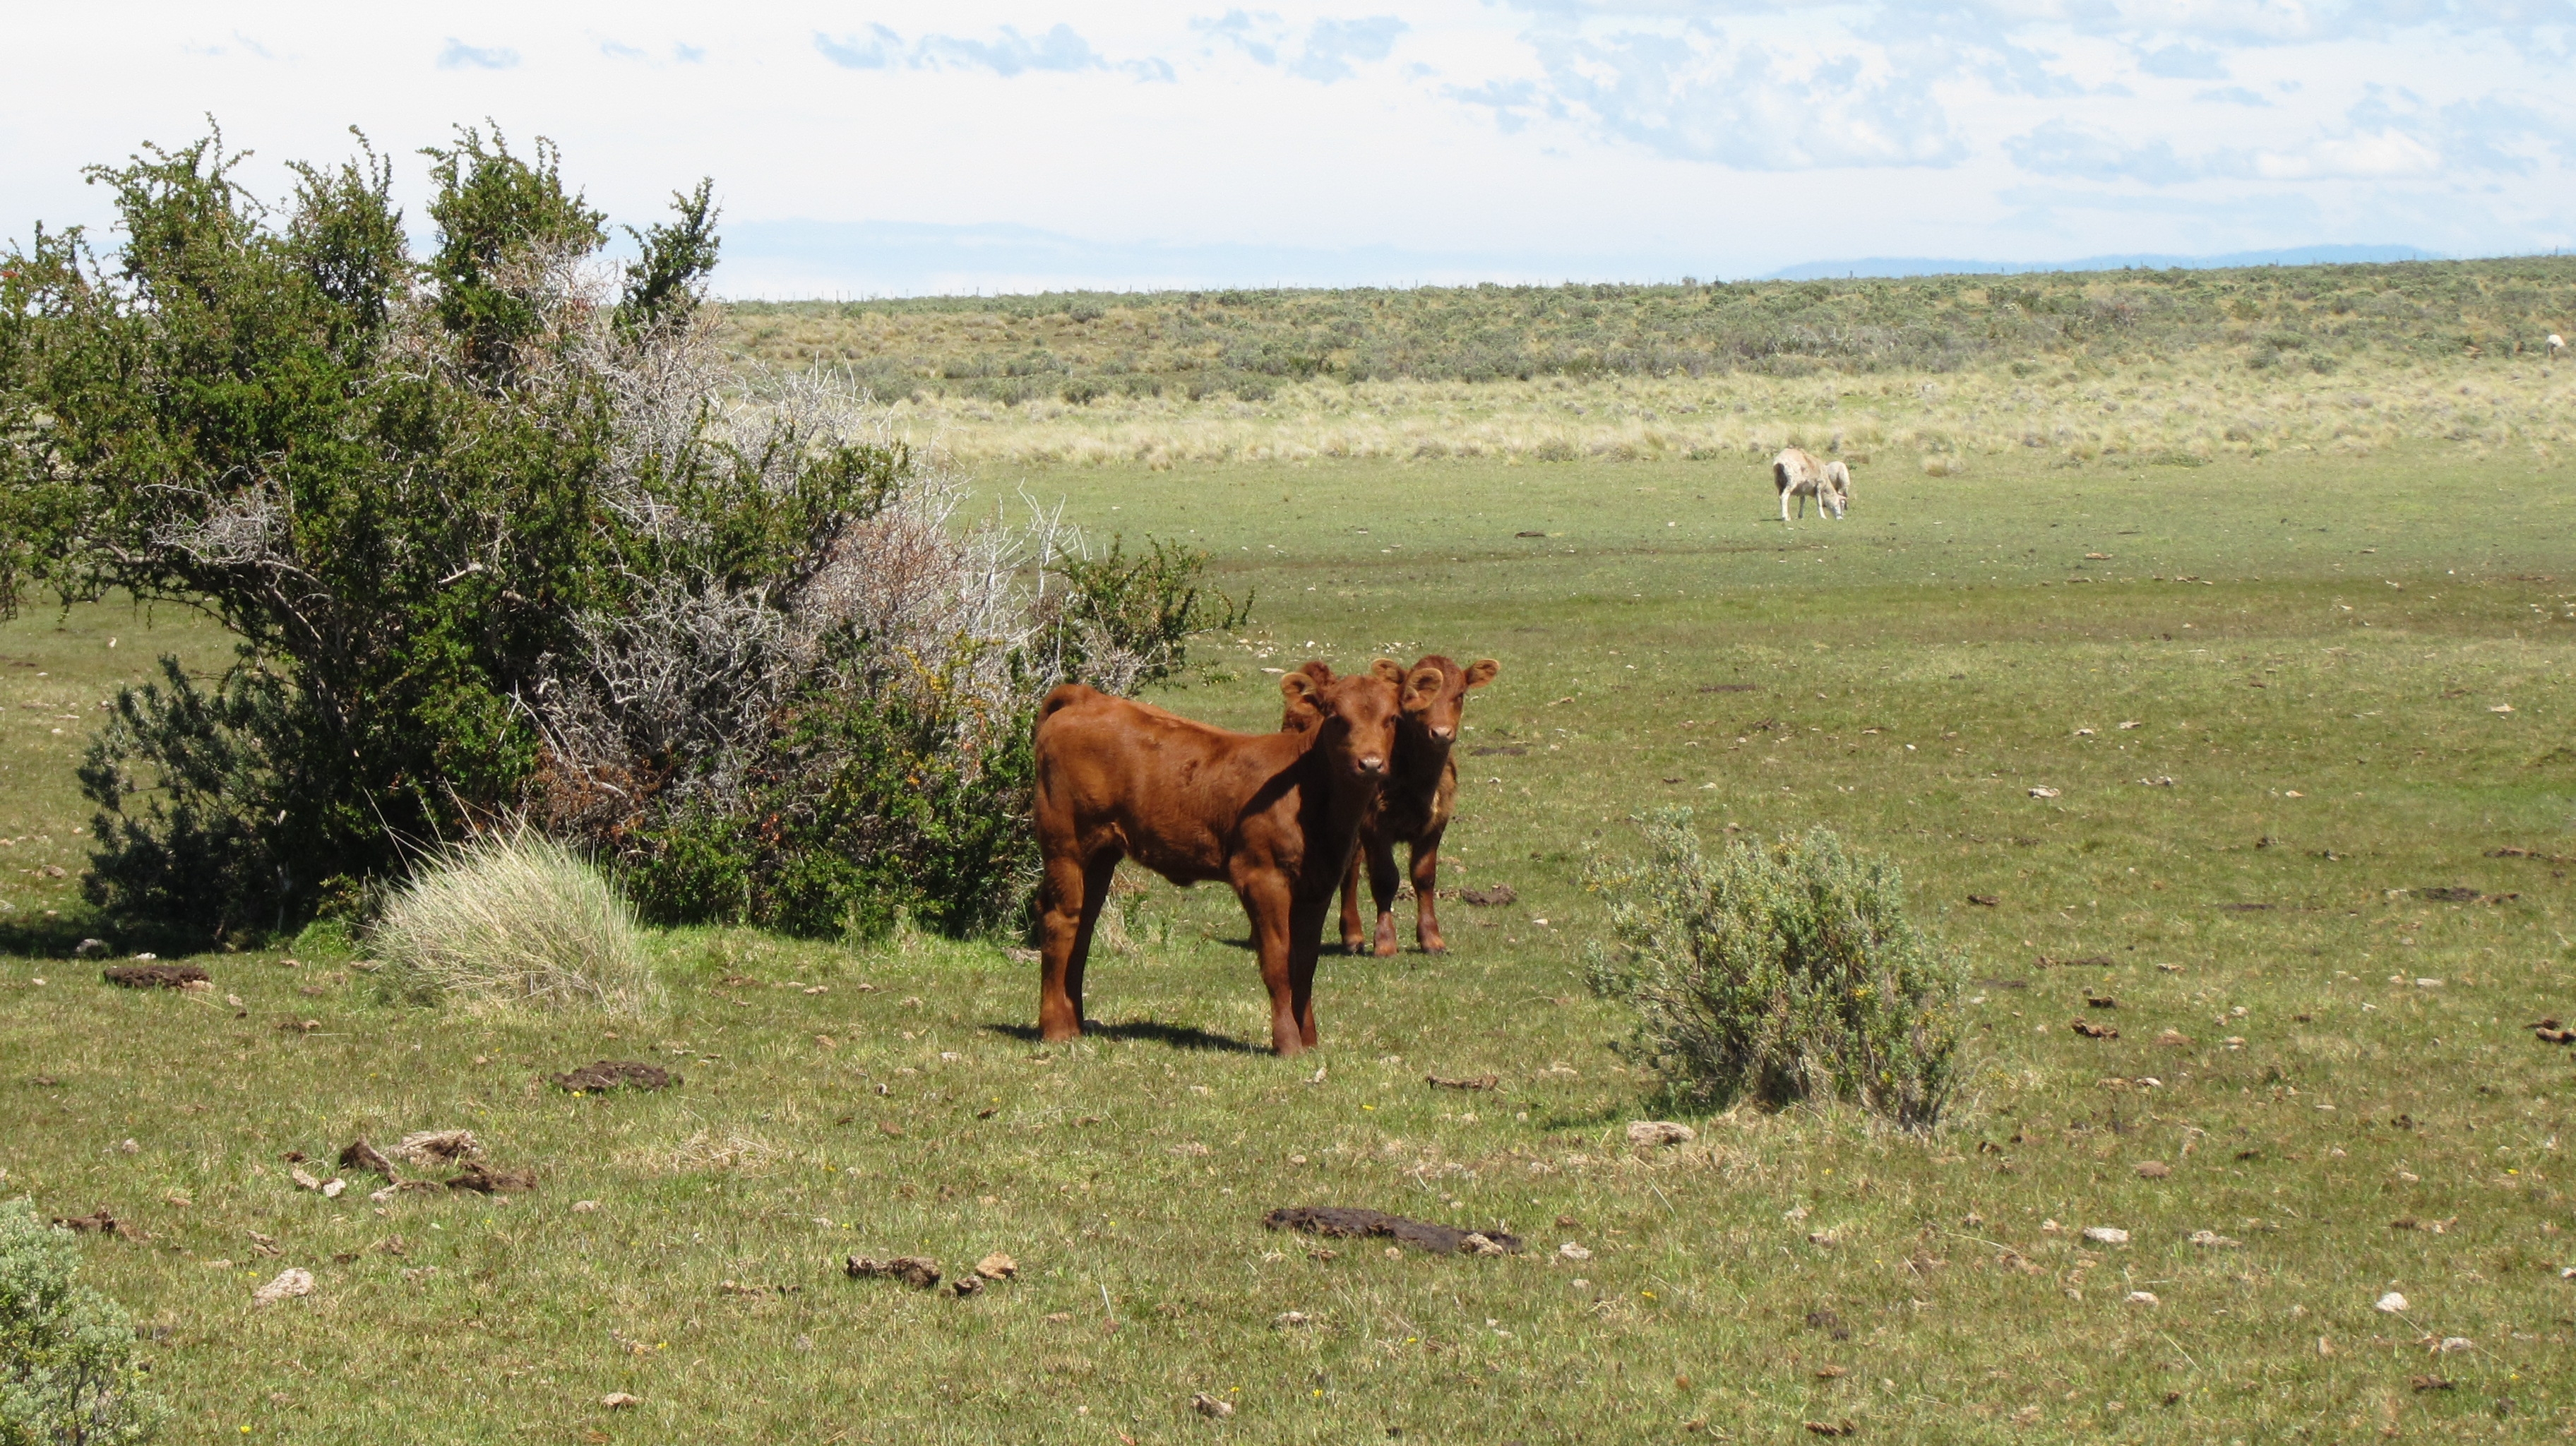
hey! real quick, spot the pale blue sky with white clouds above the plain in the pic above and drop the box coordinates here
[0,0,2576,297]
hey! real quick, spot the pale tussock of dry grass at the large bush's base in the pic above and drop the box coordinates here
[374,832,657,1015]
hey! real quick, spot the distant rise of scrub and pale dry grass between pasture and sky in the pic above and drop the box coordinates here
[724,258,2576,477]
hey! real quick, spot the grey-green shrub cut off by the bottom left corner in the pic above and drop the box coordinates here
[0,1201,170,1446]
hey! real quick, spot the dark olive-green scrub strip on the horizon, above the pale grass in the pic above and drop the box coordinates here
[732,258,2576,402]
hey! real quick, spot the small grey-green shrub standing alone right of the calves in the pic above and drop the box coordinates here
[1587,809,1965,1132]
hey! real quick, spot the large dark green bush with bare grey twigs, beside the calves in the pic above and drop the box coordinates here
[0,129,1239,943]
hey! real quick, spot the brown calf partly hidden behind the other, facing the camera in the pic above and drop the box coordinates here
[1280,652,1502,956]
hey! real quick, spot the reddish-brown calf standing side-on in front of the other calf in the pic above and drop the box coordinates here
[1035,660,1396,1054]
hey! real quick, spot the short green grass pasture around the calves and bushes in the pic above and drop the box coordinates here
[0,448,2576,1443]
